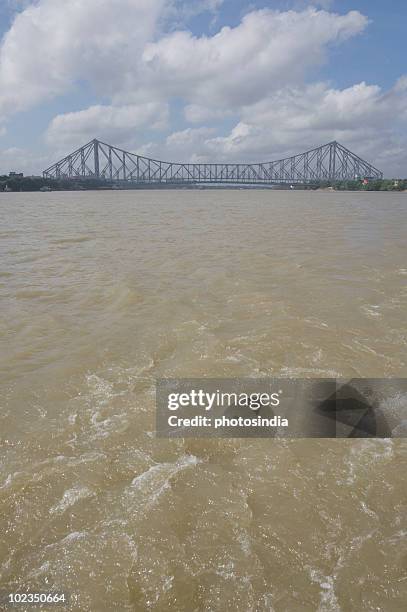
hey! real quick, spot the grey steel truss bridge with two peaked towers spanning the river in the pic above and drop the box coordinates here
[43,140,383,184]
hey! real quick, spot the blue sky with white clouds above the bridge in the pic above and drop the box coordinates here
[0,0,407,176]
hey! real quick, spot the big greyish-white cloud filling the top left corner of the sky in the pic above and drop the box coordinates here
[0,0,165,117]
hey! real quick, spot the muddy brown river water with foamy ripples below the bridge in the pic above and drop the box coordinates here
[0,190,407,612]
